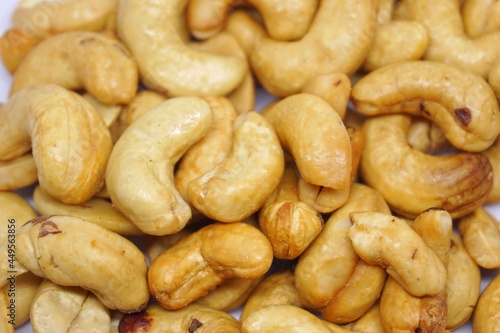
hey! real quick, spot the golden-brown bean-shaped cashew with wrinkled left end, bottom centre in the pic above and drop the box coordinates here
[148,222,273,310]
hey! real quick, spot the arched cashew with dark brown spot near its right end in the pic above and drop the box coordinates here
[352,60,500,152]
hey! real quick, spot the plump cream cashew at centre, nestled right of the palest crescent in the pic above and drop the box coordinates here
[188,111,285,222]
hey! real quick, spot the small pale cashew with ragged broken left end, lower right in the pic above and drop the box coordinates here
[348,211,446,297]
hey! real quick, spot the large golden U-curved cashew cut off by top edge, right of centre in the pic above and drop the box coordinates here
[250,0,375,96]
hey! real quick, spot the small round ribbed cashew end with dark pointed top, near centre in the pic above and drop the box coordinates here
[259,165,324,259]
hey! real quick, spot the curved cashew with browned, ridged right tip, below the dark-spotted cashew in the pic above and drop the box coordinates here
[360,114,493,218]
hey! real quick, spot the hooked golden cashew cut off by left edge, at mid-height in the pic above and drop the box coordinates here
[0,84,112,204]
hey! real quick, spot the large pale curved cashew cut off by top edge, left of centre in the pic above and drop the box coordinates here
[118,0,248,97]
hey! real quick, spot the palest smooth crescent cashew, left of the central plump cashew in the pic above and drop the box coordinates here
[106,97,213,235]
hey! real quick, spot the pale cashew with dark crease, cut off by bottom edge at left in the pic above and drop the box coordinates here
[30,280,111,333]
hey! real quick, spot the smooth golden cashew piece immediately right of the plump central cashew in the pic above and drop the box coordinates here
[262,93,352,190]
